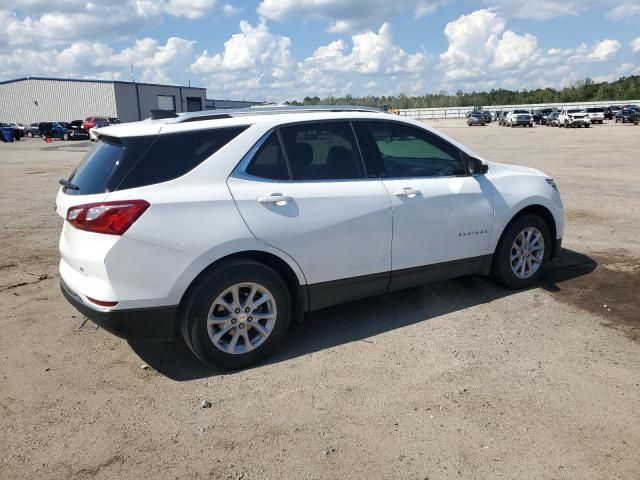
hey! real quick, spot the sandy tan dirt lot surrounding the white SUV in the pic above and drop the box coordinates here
[0,121,640,479]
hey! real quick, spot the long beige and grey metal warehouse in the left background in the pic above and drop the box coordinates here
[0,77,207,123]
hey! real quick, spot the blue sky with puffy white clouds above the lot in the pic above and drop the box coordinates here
[0,0,640,101]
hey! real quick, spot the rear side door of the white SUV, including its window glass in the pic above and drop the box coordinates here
[228,121,392,309]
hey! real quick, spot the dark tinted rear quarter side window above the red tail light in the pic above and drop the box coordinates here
[117,127,247,190]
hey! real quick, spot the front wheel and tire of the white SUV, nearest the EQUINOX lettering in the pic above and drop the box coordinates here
[491,213,551,290]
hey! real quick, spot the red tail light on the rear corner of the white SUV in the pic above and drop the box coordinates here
[67,200,149,235]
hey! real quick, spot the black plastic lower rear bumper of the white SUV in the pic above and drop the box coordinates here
[60,281,178,341]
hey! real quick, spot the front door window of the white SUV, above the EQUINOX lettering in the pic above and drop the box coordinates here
[367,122,467,178]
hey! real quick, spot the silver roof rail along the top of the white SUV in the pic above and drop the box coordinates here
[168,105,388,123]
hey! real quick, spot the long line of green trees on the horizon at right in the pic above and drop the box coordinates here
[285,75,640,109]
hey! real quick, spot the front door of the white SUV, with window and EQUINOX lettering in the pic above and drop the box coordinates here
[366,121,494,289]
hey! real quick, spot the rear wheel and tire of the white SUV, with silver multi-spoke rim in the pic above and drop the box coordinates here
[180,259,291,369]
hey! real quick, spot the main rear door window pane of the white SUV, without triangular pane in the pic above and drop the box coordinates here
[281,122,364,180]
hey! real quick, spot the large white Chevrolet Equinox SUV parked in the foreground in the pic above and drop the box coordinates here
[56,107,564,368]
